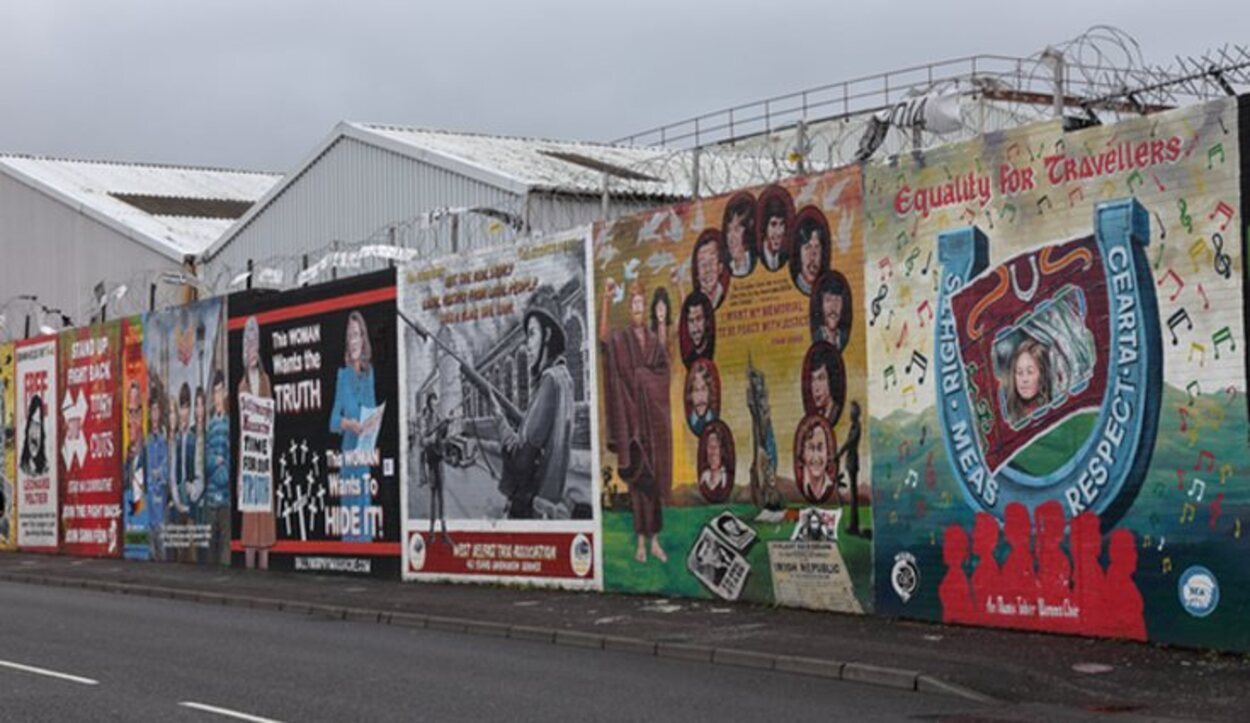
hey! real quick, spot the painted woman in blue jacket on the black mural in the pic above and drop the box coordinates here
[330,311,381,542]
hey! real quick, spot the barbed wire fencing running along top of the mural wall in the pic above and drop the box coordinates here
[0,25,1250,339]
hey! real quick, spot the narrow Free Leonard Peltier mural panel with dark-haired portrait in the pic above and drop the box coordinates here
[15,336,60,552]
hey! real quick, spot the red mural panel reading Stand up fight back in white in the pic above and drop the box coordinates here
[58,321,124,557]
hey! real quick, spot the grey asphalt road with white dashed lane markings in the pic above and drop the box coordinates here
[0,583,980,723]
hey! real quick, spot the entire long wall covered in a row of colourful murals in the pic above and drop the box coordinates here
[0,92,1250,650]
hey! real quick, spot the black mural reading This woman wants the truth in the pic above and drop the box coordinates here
[227,271,403,578]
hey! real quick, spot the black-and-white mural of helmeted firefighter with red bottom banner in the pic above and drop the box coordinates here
[400,231,599,587]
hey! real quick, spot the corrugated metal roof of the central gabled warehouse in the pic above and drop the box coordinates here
[346,123,690,198]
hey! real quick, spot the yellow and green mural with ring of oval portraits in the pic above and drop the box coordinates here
[593,169,874,612]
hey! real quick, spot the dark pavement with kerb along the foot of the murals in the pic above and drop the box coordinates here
[0,554,1250,720]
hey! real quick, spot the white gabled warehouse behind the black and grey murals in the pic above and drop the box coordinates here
[201,123,691,290]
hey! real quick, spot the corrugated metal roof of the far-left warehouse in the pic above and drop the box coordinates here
[0,154,283,260]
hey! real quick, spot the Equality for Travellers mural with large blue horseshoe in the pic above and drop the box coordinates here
[864,99,1250,649]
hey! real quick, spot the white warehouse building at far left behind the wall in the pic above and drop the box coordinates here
[0,155,280,339]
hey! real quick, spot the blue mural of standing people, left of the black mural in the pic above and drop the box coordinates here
[143,299,234,565]
